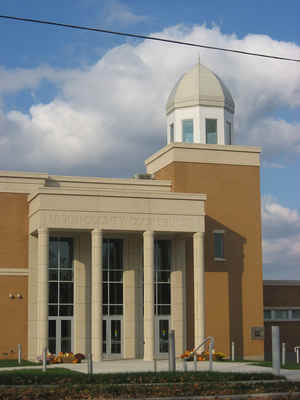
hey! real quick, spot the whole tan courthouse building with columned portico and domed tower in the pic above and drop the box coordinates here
[0,64,264,360]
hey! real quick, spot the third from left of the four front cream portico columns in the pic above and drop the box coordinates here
[144,231,154,360]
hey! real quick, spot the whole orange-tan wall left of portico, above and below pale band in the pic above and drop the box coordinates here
[0,193,28,358]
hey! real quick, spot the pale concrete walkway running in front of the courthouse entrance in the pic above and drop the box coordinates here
[0,360,300,381]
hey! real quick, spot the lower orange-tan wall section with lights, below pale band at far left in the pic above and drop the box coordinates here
[0,276,28,358]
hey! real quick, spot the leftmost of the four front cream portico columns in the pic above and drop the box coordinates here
[37,228,49,355]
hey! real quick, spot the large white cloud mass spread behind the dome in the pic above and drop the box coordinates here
[0,24,300,176]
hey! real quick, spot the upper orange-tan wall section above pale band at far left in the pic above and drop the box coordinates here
[0,193,28,268]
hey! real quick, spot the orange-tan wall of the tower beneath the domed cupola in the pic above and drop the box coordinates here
[155,162,264,357]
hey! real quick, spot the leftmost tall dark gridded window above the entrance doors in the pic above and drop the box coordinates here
[48,237,74,317]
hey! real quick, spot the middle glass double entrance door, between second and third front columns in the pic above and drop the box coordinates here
[102,316,123,359]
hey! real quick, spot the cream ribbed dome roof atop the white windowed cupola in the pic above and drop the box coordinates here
[166,63,234,114]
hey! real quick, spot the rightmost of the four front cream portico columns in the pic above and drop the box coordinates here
[193,232,205,346]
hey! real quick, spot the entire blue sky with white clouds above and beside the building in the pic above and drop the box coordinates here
[0,0,300,279]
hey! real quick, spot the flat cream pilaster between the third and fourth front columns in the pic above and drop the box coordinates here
[171,238,186,356]
